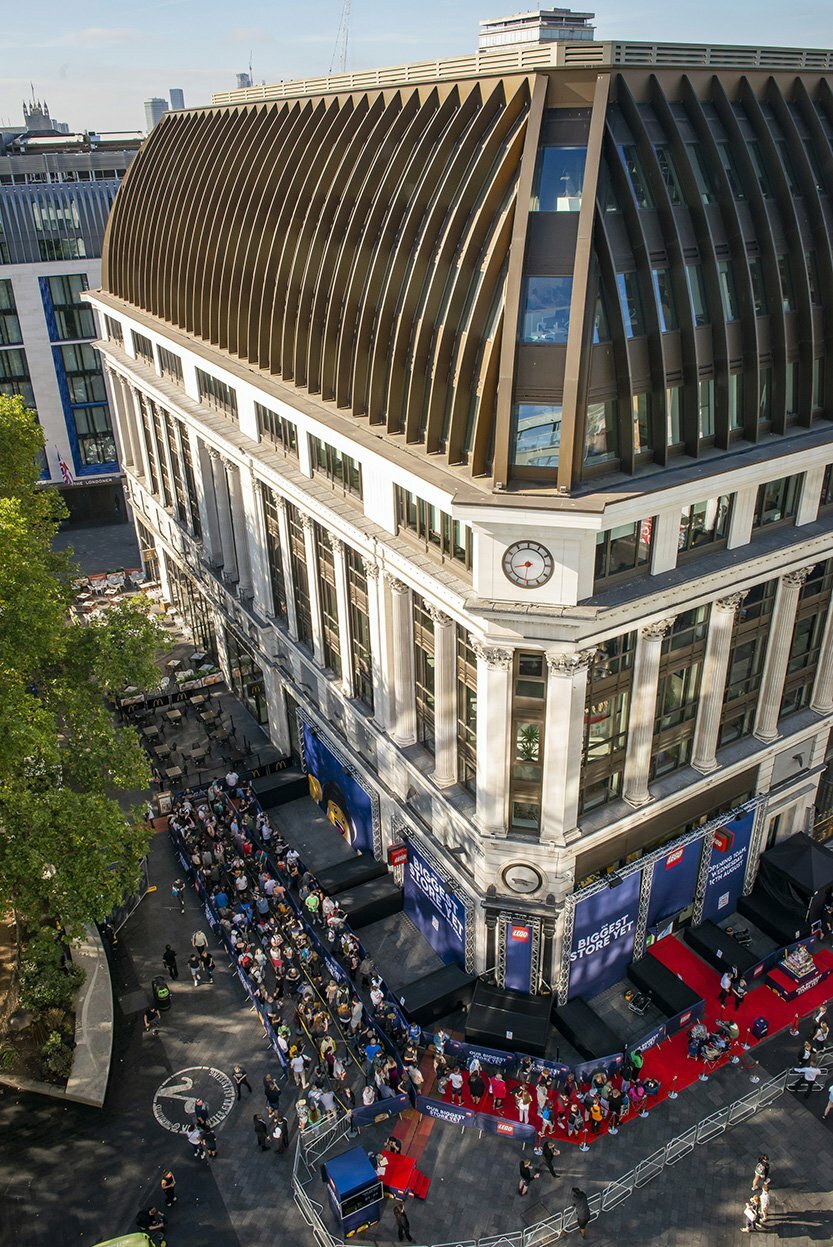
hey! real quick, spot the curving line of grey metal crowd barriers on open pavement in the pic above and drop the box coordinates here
[292,1061,798,1247]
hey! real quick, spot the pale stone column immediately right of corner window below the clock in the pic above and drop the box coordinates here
[541,650,596,844]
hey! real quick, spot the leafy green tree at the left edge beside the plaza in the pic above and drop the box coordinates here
[0,395,161,933]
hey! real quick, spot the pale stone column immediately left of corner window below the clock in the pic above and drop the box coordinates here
[471,640,513,837]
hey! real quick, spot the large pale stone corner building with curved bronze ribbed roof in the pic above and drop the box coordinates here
[91,31,833,994]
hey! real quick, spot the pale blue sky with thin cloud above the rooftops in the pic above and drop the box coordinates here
[0,0,833,131]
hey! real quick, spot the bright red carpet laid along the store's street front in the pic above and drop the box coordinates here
[433,935,833,1146]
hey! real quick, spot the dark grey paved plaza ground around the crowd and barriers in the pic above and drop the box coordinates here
[0,802,833,1247]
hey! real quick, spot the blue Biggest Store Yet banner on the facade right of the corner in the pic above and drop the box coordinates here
[567,870,642,1000]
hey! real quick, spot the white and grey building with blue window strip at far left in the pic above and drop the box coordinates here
[0,105,141,516]
